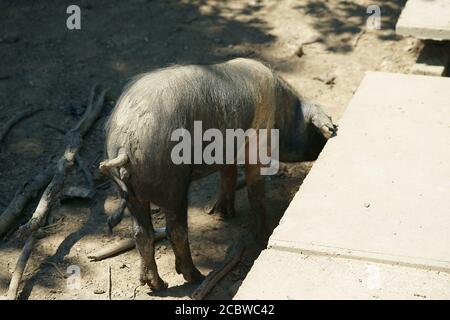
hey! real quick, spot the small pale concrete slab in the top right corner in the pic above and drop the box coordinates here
[398,0,450,40]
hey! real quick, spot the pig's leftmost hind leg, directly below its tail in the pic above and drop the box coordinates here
[128,197,167,290]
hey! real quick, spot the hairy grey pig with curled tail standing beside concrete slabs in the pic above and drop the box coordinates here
[100,58,337,290]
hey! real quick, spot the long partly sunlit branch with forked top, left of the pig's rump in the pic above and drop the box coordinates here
[18,86,107,238]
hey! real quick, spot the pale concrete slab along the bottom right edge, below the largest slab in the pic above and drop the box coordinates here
[234,249,450,300]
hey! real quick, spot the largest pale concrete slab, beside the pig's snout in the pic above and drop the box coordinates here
[269,72,450,272]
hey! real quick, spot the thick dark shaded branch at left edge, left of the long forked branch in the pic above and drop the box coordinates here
[0,166,54,236]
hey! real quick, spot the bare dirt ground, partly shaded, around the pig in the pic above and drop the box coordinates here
[0,0,419,299]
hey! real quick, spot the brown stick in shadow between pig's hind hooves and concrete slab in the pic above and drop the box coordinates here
[192,241,244,300]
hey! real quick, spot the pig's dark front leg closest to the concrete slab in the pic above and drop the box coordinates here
[245,164,269,246]
